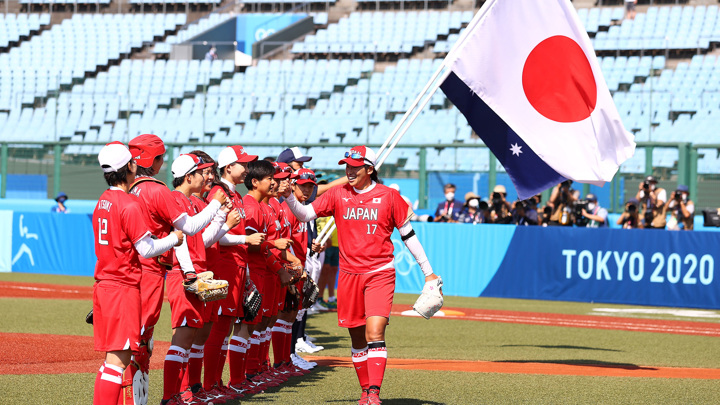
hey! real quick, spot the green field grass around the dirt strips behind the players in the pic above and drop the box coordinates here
[0,274,720,405]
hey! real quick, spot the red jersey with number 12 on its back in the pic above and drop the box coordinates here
[93,187,150,287]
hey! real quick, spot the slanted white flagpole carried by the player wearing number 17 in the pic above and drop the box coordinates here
[317,7,490,245]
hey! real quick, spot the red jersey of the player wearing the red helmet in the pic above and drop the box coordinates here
[130,178,187,274]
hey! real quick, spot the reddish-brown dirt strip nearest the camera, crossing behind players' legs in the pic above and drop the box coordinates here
[0,333,720,380]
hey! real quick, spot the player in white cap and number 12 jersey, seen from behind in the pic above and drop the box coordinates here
[93,142,183,404]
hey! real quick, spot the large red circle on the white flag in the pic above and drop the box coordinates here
[523,35,597,122]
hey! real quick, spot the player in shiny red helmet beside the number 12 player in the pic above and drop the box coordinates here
[129,134,226,387]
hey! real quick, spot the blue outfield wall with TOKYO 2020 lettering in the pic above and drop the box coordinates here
[0,211,720,308]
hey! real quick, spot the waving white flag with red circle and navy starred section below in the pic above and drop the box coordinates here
[441,0,635,198]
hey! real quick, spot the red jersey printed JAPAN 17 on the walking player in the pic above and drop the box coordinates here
[312,184,409,274]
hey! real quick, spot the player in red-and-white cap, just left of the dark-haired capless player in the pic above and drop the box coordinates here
[203,145,265,400]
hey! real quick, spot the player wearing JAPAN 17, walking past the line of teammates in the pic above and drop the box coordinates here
[286,146,438,405]
